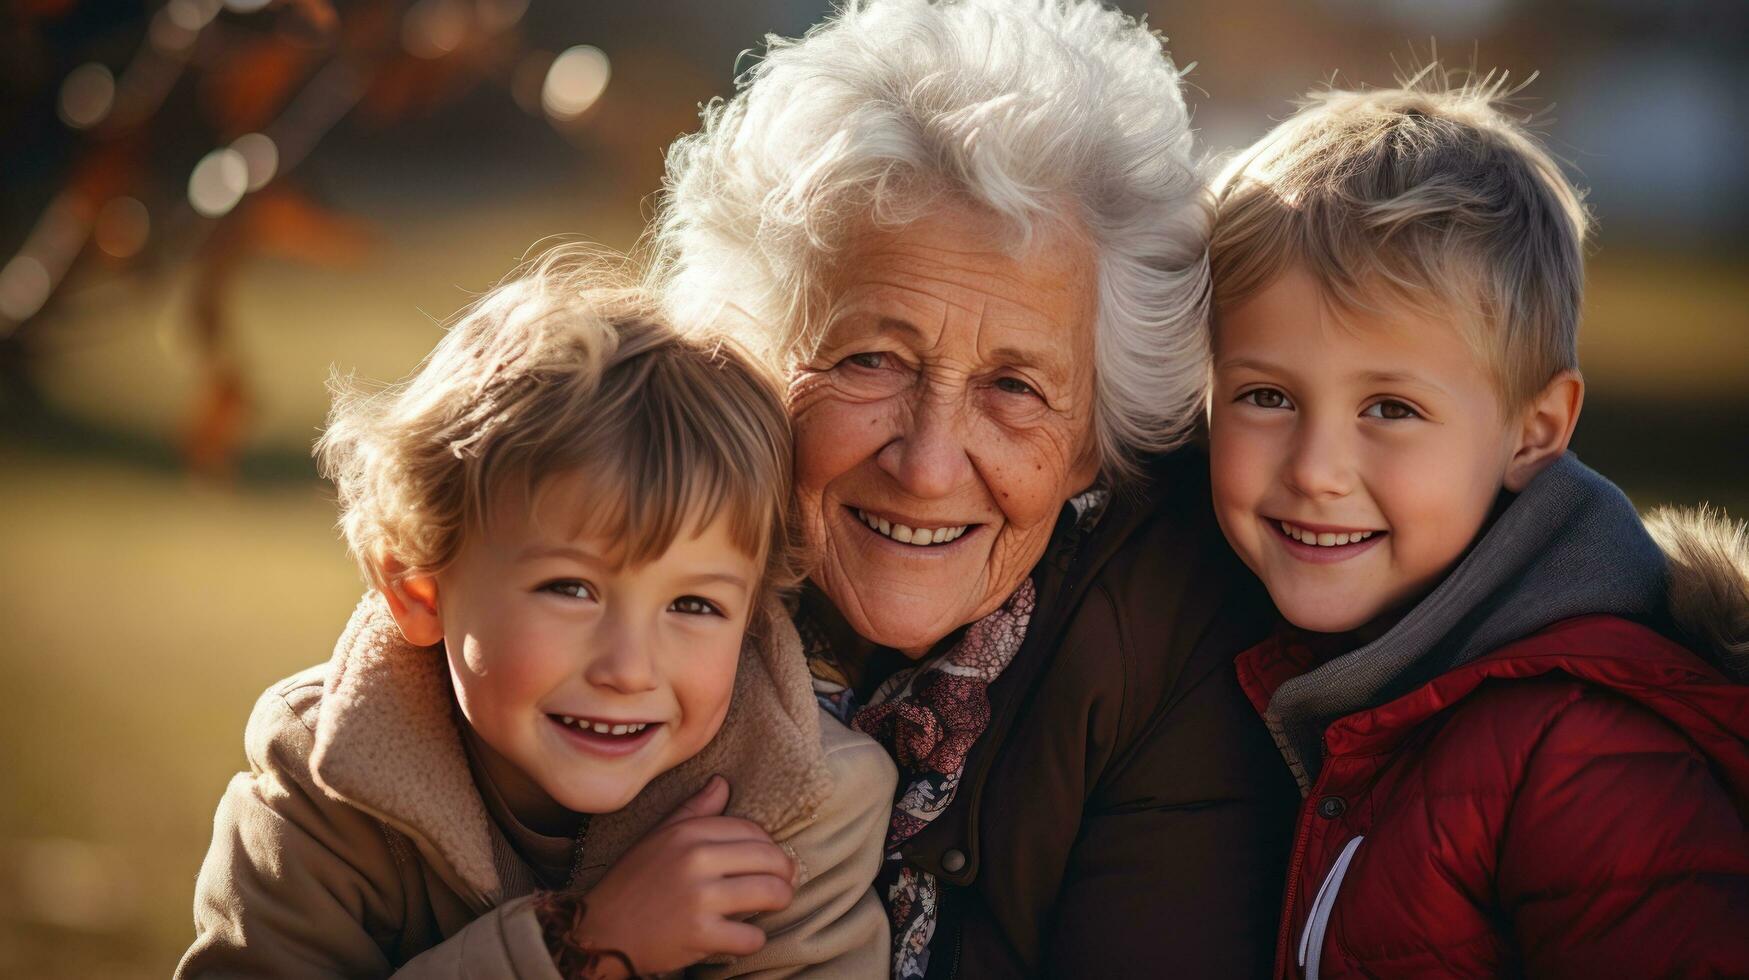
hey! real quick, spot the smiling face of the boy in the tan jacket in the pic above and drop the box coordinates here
[437,476,759,819]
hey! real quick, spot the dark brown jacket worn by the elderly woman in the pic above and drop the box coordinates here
[888,450,1300,978]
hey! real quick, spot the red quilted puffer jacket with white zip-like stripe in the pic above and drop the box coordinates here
[1238,616,1749,978]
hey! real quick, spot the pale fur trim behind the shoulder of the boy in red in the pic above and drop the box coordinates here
[1646,506,1749,684]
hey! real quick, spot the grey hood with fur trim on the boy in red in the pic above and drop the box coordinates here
[1263,453,1749,789]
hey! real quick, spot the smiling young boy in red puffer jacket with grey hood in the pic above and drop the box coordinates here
[1210,72,1749,978]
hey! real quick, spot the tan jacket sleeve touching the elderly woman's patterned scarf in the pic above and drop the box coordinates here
[687,712,899,980]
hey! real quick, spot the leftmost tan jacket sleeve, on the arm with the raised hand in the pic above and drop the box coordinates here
[177,688,558,980]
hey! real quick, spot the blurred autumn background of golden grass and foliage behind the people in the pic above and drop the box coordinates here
[0,0,1749,977]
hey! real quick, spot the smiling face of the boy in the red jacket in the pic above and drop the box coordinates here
[1209,270,1516,632]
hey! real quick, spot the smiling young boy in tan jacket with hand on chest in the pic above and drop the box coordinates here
[178,254,895,978]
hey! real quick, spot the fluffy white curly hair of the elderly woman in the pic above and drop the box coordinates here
[651,0,1209,478]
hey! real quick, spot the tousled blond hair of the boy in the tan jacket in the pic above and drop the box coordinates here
[317,249,796,623]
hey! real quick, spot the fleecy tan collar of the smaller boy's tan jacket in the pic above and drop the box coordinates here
[311,592,833,905]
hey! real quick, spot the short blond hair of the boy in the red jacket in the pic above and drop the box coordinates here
[1210,65,1588,408]
